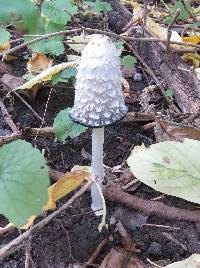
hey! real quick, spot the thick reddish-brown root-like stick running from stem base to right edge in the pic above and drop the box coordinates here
[103,186,200,222]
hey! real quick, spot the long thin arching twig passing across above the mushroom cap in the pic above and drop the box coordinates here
[0,27,200,58]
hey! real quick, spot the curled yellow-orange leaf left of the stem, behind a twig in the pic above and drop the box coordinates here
[20,170,90,230]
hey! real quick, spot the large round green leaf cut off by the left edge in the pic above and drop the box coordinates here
[0,140,49,227]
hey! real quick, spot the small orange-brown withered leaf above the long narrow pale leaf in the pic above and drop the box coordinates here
[27,52,53,74]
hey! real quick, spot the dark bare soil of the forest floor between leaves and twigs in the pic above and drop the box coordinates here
[0,1,200,268]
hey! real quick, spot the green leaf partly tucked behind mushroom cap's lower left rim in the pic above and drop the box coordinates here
[53,108,87,141]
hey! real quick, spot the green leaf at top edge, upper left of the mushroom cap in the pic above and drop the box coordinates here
[42,0,78,25]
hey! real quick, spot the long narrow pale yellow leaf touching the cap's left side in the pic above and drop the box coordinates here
[14,61,78,90]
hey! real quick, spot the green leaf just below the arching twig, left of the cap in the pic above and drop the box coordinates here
[29,39,65,56]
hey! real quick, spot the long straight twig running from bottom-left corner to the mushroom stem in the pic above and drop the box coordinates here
[0,181,92,260]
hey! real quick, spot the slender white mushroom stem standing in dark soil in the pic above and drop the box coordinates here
[91,127,104,216]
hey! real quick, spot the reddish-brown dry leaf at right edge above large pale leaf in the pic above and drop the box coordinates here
[155,119,200,142]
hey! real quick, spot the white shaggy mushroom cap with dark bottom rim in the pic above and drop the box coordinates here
[70,35,128,128]
